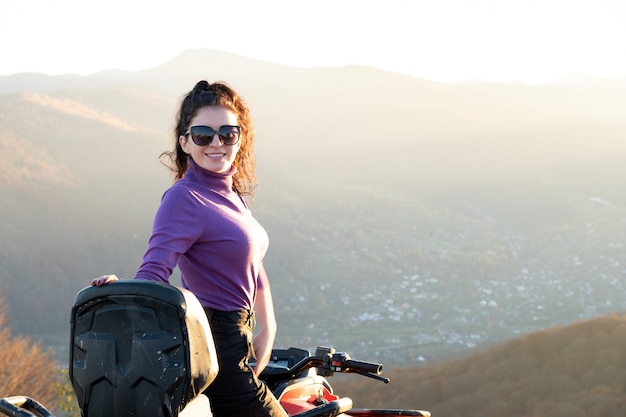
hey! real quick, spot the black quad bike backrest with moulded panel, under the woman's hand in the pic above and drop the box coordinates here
[69,280,218,417]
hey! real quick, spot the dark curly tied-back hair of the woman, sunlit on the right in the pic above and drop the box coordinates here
[160,80,258,196]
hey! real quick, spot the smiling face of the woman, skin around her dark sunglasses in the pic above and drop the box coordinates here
[178,106,241,174]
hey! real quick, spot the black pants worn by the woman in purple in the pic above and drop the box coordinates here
[204,308,288,417]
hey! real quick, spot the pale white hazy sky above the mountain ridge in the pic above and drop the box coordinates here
[0,0,626,83]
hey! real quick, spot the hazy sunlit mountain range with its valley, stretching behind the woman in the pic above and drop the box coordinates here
[0,50,626,365]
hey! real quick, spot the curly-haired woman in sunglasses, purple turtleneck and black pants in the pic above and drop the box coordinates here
[92,81,287,417]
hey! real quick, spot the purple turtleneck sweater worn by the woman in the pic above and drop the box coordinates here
[135,158,269,311]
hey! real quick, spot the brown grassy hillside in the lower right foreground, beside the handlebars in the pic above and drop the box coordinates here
[330,315,626,417]
